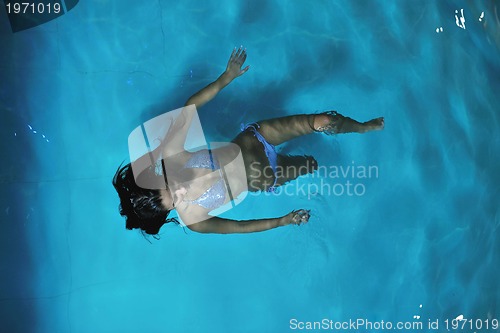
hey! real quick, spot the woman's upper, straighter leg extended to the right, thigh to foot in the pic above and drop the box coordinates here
[258,111,384,146]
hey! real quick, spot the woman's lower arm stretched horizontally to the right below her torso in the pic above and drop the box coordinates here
[188,209,310,234]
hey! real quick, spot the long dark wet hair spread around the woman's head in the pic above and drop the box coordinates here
[113,163,179,239]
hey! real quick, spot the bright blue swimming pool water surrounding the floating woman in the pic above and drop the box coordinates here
[0,0,500,333]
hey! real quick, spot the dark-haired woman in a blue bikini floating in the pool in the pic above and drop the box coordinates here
[113,48,384,235]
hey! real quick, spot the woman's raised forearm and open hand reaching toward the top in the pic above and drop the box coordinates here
[186,47,250,109]
